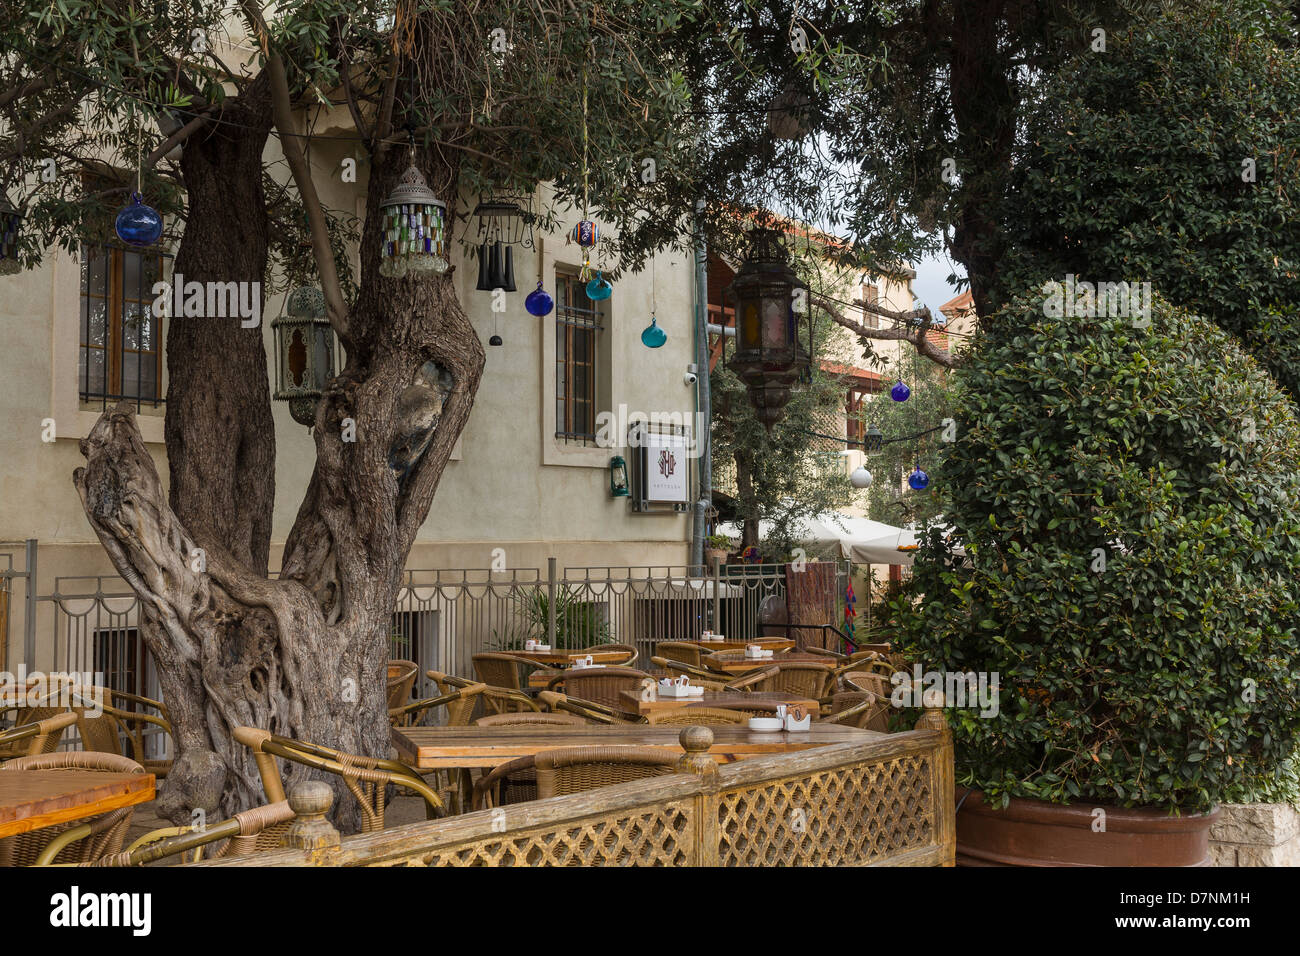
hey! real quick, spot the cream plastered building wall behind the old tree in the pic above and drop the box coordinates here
[0,117,694,581]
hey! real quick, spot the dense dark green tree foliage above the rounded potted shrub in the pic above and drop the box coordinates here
[1001,4,1300,397]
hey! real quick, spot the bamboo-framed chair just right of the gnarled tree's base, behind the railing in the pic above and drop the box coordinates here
[234,727,443,832]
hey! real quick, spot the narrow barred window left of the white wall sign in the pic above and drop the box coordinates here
[555,271,602,445]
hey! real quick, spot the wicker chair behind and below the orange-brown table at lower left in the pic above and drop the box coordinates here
[0,750,144,866]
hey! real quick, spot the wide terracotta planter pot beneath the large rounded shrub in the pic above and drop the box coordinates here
[957,787,1219,866]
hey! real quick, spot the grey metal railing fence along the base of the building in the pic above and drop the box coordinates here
[0,542,848,723]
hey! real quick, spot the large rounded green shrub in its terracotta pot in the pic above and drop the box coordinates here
[896,294,1300,865]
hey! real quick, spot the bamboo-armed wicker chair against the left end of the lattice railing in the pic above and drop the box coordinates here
[90,800,295,866]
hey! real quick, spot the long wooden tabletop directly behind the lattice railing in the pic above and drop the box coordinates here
[393,723,885,770]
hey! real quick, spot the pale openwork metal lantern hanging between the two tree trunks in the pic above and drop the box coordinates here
[270,285,335,428]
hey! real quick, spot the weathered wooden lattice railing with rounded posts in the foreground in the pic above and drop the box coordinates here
[198,710,956,866]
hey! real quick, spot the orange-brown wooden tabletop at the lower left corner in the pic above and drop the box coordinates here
[0,770,153,836]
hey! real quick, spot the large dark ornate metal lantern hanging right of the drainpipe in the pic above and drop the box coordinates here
[724,229,811,431]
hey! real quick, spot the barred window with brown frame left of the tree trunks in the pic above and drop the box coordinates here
[77,245,168,407]
